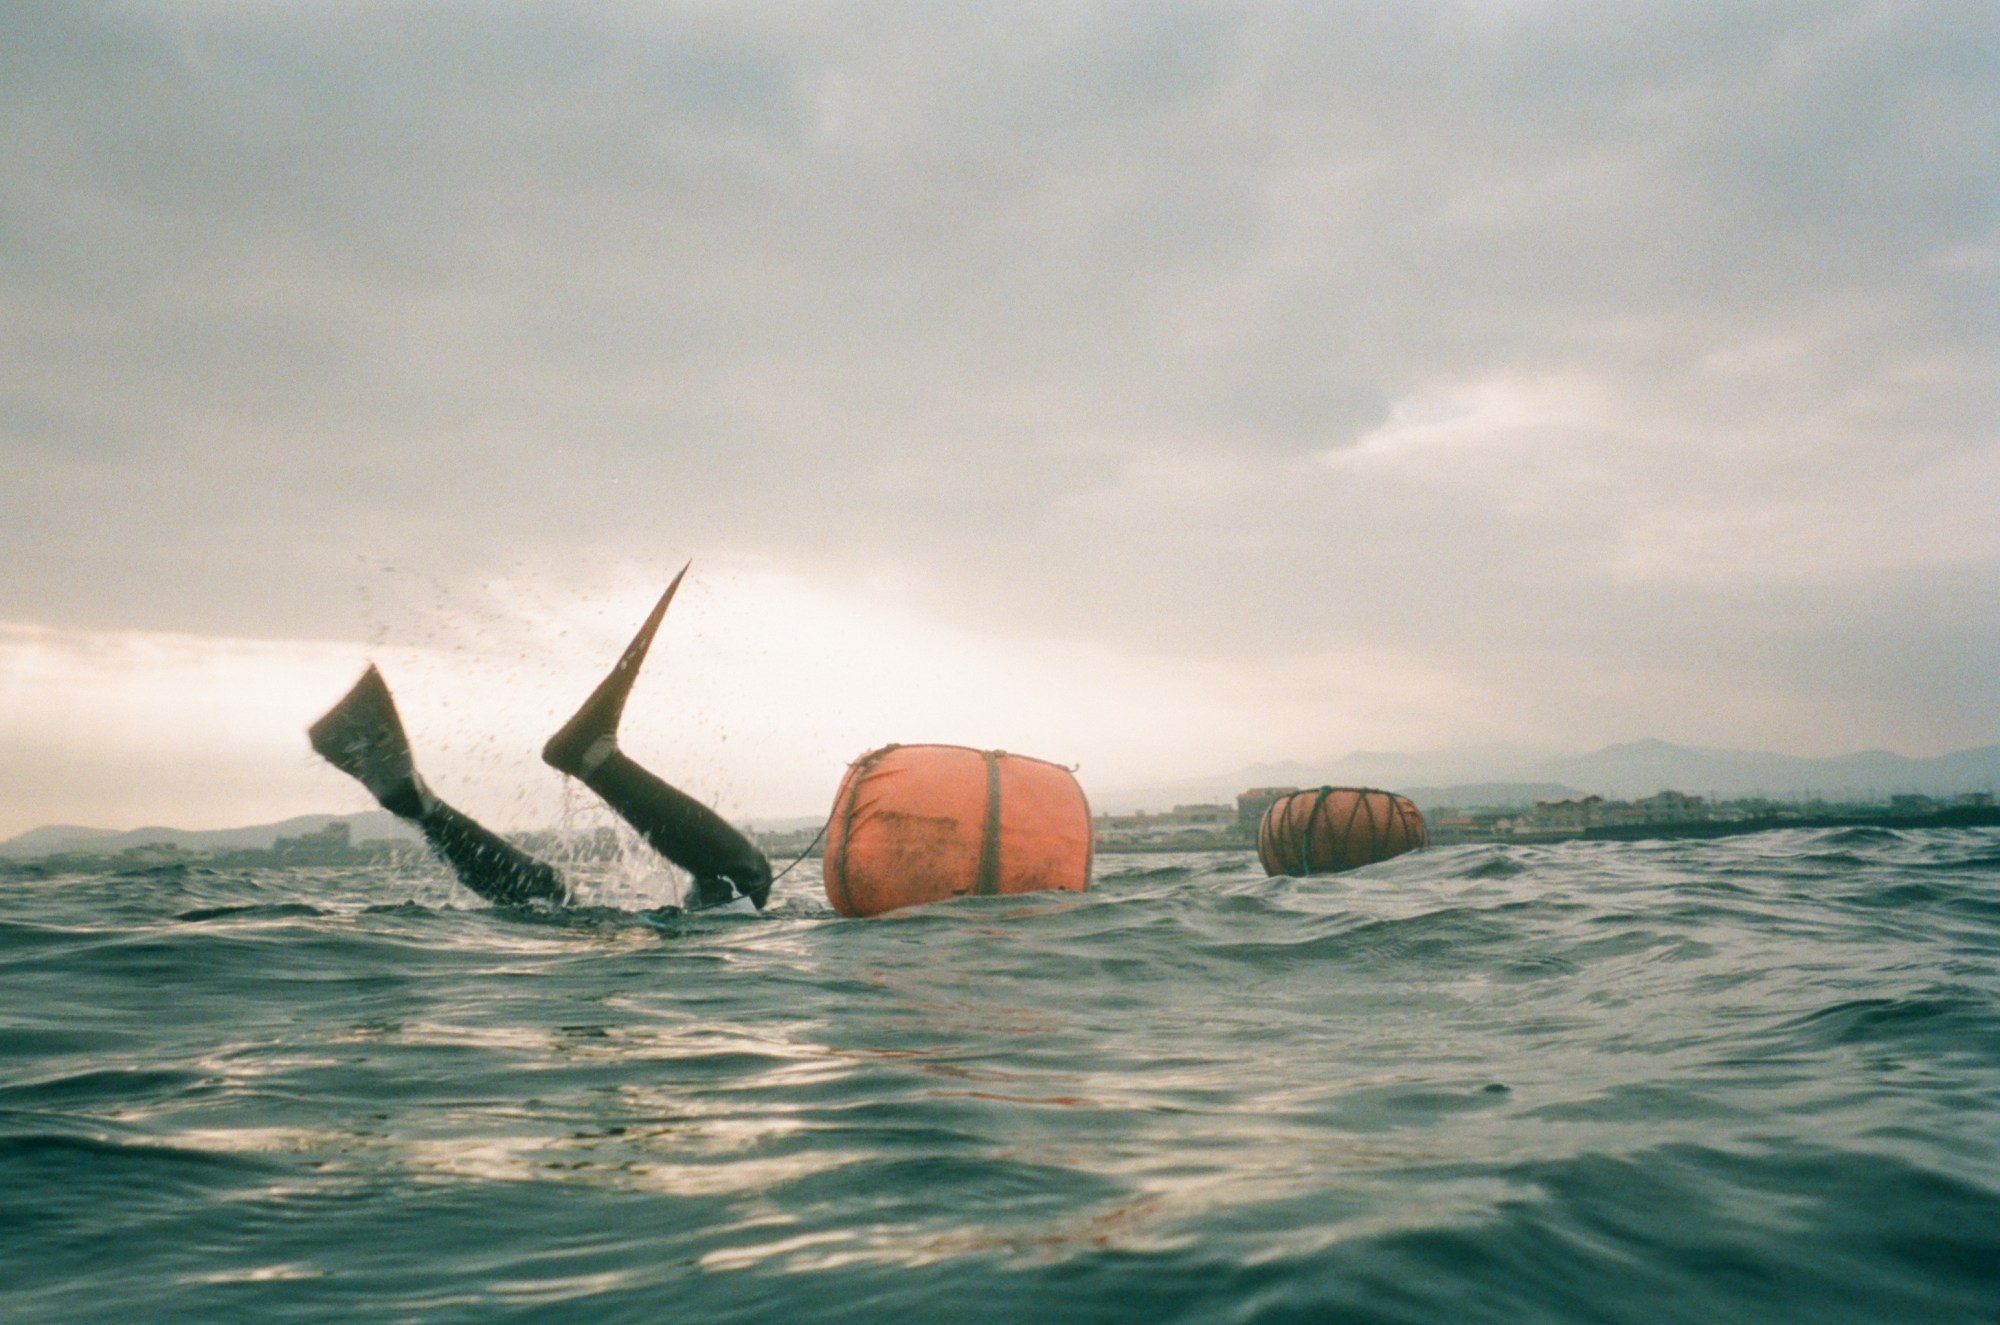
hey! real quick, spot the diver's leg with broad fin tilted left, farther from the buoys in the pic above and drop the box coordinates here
[306,667,568,905]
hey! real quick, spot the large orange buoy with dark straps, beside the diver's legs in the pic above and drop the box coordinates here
[820,745,1090,915]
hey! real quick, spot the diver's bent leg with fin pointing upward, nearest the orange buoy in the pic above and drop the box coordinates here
[542,566,770,909]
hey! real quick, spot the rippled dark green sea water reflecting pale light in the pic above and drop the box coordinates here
[0,829,2000,1325]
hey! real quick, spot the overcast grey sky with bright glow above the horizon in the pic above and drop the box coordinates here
[0,0,2000,837]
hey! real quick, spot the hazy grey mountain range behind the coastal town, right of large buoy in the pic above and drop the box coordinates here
[1088,741,2000,813]
